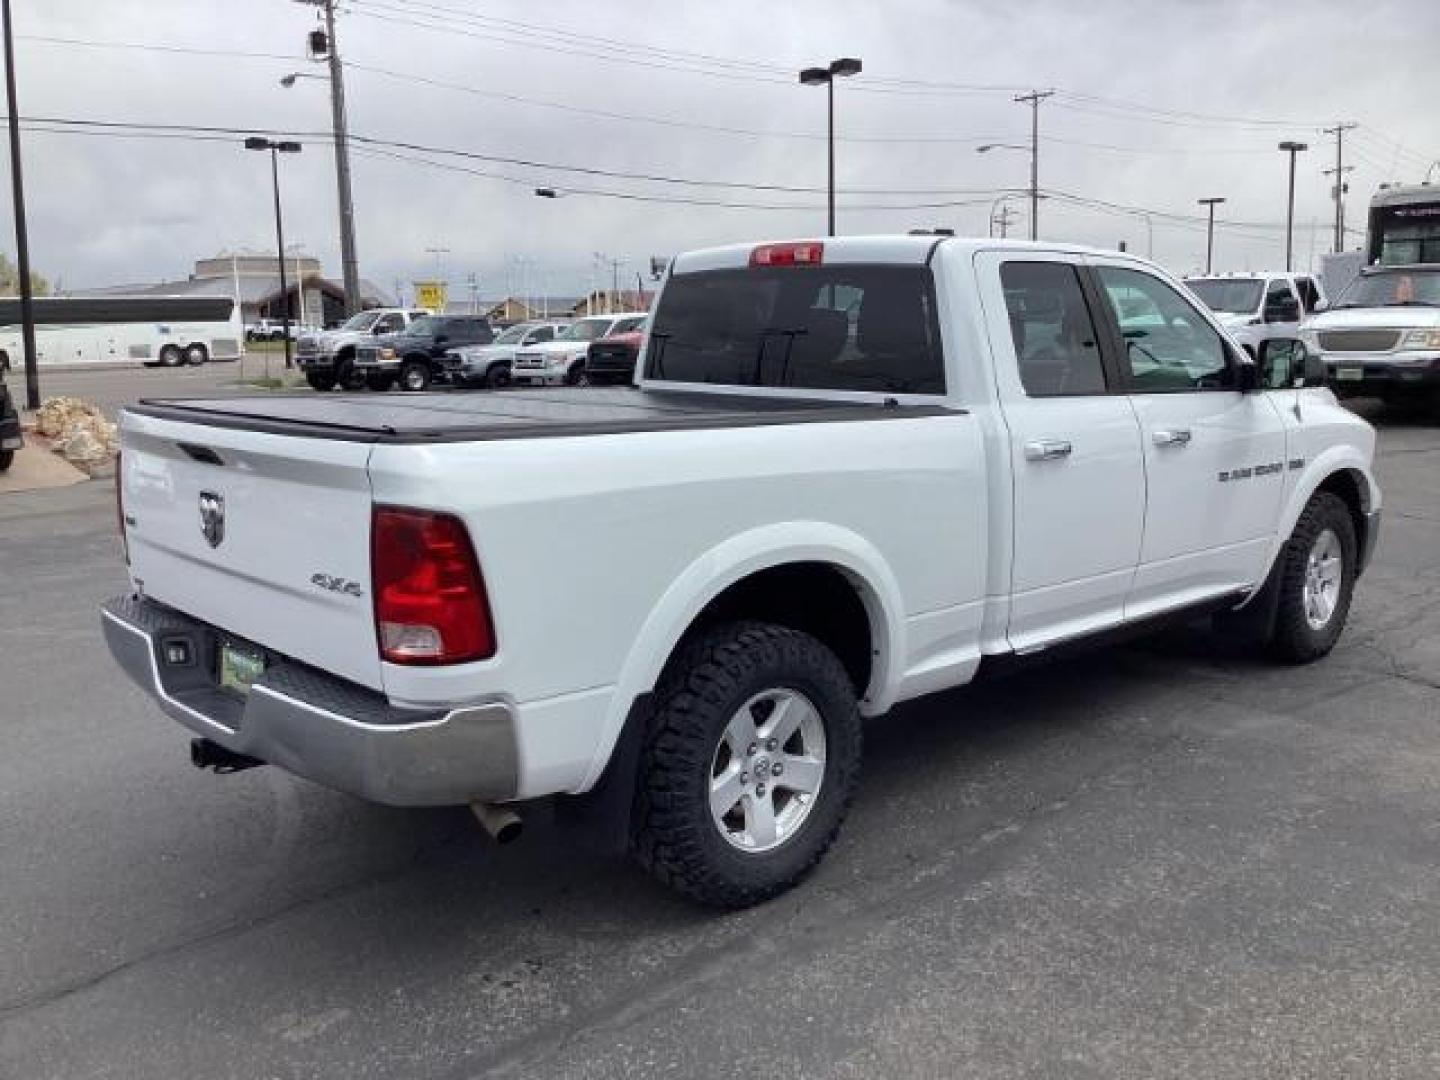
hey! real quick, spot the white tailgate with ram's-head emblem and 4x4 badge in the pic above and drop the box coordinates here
[121,410,382,690]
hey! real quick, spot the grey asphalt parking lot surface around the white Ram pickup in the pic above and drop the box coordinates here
[0,385,1440,1080]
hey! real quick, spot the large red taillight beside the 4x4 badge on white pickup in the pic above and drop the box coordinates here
[370,507,495,664]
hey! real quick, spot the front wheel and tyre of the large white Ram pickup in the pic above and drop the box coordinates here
[1270,491,1359,664]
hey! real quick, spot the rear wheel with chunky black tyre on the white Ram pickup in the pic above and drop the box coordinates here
[632,622,861,909]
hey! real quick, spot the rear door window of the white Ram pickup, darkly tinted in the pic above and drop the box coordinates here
[999,262,1106,397]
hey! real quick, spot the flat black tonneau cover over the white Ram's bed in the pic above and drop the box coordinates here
[125,387,953,442]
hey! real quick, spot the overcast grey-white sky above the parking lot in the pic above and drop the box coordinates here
[11,0,1440,297]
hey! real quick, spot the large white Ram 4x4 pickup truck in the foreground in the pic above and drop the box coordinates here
[102,236,1381,907]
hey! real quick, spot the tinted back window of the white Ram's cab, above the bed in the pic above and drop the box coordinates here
[645,265,945,393]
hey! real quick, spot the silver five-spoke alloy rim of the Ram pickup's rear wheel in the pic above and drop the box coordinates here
[710,688,825,852]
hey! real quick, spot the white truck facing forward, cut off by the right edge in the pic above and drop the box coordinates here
[1300,265,1440,415]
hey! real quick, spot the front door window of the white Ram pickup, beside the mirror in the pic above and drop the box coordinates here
[1096,266,1231,393]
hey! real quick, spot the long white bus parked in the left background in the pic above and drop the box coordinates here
[0,297,245,370]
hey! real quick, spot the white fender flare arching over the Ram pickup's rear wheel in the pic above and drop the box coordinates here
[580,521,906,791]
